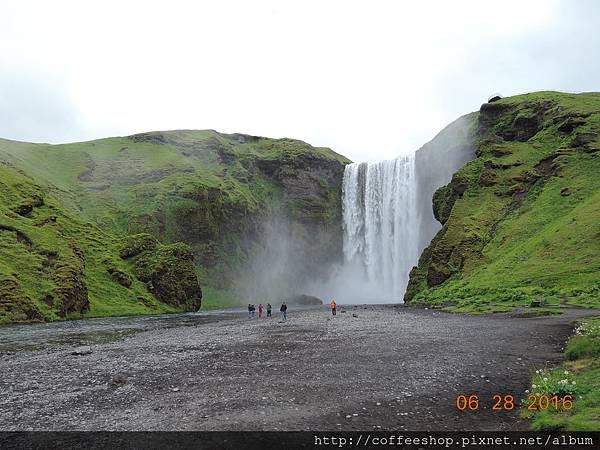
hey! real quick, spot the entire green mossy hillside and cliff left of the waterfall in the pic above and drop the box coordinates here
[0,131,348,322]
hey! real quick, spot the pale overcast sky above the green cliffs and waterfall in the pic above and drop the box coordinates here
[0,0,600,161]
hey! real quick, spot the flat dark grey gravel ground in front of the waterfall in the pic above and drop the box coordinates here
[0,306,598,431]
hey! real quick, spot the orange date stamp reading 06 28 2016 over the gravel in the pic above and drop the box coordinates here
[455,394,573,411]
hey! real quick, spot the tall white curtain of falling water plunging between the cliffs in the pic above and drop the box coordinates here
[342,155,419,302]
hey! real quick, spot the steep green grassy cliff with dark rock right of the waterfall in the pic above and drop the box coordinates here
[405,92,600,310]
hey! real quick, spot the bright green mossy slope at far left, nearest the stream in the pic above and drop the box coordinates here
[0,163,201,323]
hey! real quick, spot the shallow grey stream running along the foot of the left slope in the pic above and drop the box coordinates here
[0,308,244,354]
